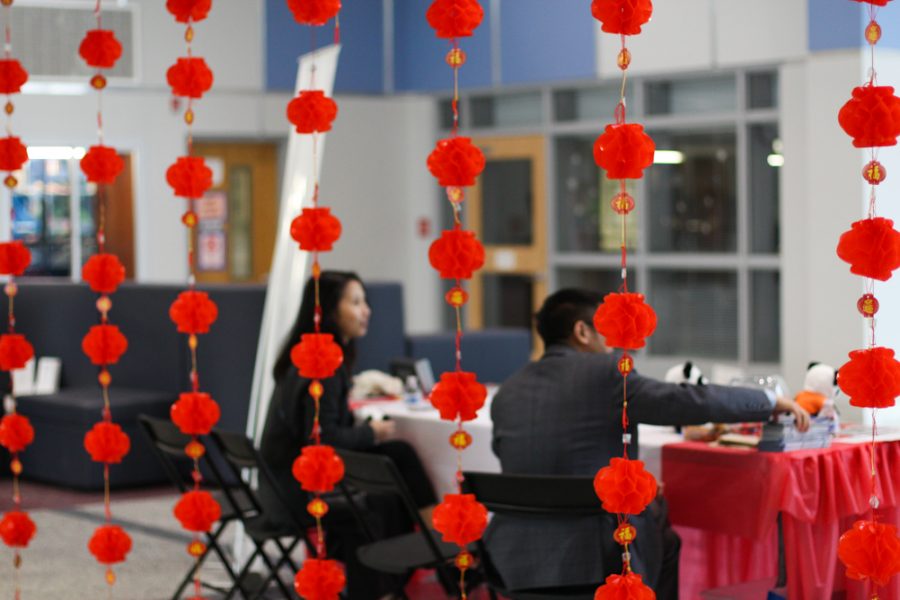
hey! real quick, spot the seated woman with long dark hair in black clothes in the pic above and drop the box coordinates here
[259,271,437,600]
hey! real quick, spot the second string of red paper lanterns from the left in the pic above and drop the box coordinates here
[78,0,132,586]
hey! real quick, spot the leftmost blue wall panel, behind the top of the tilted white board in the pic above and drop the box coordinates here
[265,0,384,94]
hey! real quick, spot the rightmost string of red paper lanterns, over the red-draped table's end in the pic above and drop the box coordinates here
[837,0,900,599]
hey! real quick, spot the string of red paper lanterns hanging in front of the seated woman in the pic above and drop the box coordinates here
[286,0,346,600]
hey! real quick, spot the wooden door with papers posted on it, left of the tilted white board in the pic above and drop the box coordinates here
[194,142,278,283]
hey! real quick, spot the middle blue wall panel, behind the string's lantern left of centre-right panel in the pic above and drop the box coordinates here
[394,0,492,92]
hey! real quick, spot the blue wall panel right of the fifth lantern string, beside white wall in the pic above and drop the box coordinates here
[500,0,597,85]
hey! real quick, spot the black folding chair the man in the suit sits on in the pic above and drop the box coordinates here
[463,472,615,600]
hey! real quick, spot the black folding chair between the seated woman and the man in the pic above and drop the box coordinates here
[337,449,459,598]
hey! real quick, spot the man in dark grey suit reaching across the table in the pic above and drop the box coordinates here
[485,289,809,599]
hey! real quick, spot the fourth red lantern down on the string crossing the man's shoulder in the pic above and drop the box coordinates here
[594,458,656,515]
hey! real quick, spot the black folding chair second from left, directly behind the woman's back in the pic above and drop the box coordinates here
[210,429,315,600]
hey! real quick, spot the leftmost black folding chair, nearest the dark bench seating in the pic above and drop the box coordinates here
[138,415,256,600]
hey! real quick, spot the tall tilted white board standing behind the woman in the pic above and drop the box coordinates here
[247,45,341,442]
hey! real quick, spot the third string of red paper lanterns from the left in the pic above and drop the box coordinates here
[166,0,222,600]
